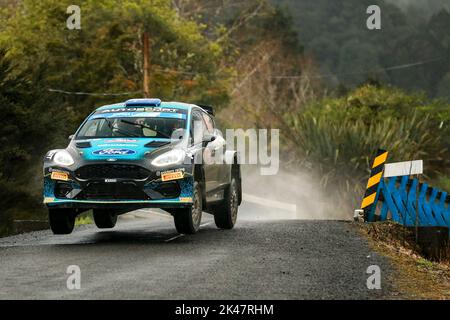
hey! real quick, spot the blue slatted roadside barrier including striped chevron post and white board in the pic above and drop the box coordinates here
[355,149,450,229]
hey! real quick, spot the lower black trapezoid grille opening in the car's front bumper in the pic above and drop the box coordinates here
[77,182,150,200]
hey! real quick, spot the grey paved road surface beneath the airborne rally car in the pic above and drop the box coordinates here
[0,206,390,299]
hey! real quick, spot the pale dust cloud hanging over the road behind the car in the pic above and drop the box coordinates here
[239,165,352,220]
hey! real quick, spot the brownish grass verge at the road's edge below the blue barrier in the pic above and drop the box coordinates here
[357,222,450,300]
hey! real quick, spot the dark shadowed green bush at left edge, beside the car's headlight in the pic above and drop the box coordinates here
[0,51,58,230]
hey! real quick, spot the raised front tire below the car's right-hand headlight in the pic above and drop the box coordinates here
[173,181,203,234]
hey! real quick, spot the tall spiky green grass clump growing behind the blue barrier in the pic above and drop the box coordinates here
[289,112,444,210]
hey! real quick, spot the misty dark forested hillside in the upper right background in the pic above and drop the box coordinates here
[272,0,450,97]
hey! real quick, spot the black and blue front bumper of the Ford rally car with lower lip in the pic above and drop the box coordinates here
[43,164,194,210]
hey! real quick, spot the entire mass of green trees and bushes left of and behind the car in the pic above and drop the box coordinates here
[0,0,232,232]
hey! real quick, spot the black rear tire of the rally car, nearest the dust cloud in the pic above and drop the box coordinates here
[214,177,239,229]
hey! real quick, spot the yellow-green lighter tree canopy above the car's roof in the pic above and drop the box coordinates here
[0,0,229,123]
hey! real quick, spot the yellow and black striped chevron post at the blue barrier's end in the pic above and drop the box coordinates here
[361,149,388,213]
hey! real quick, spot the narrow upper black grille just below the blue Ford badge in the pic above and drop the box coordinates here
[75,164,152,180]
